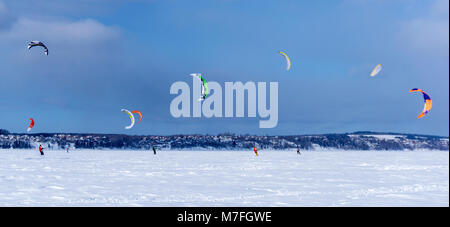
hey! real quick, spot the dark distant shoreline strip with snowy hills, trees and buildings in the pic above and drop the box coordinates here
[0,132,449,151]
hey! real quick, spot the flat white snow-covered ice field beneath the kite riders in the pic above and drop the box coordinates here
[0,149,449,206]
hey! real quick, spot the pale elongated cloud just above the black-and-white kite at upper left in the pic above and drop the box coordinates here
[0,0,120,54]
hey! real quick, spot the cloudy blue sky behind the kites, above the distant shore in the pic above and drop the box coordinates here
[0,0,449,136]
